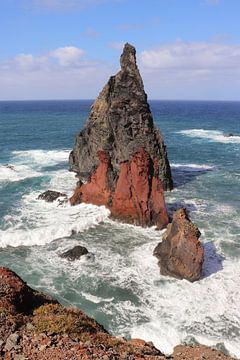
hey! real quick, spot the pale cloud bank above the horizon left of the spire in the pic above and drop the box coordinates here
[0,46,114,100]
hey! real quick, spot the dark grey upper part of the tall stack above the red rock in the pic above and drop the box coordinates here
[70,44,173,190]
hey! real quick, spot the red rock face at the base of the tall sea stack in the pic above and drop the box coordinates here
[70,148,169,229]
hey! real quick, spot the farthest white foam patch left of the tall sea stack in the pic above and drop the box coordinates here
[12,149,70,166]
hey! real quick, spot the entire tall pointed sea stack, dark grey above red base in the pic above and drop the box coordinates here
[70,44,173,228]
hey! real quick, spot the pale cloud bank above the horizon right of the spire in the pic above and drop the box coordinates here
[139,41,240,100]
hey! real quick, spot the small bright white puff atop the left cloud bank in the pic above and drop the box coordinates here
[49,46,85,66]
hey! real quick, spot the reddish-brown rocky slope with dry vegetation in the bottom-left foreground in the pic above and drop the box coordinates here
[0,268,230,360]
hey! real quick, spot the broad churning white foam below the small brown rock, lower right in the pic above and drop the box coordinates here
[128,239,240,356]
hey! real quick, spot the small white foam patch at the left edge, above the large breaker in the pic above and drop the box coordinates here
[0,165,42,182]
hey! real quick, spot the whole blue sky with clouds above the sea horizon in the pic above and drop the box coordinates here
[0,0,240,100]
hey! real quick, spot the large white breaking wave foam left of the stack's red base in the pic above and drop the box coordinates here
[0,198,109,247]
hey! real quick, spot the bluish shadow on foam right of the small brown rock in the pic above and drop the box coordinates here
[202,241,225,278]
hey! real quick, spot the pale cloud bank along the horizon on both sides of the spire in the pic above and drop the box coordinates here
[0,41,240,100]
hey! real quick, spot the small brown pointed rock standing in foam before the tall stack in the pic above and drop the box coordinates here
[154,209,204,282]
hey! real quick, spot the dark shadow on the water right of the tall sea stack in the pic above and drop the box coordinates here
[171,165,213,188]
